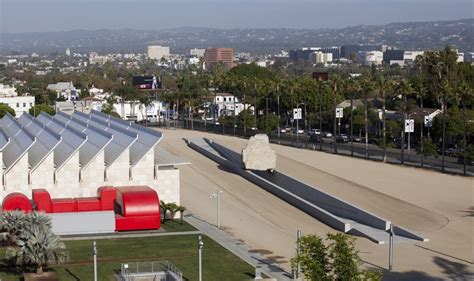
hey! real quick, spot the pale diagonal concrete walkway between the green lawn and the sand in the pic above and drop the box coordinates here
[184,215,292,281]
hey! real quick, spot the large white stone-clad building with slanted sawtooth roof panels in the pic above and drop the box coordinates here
[0,111,186,208]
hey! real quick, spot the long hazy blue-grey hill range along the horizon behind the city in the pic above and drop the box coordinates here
[0,19,474,55]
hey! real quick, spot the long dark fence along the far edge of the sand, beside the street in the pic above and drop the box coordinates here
[146,119,474,176]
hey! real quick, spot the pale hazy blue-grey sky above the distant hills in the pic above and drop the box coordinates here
[0,0,474,32]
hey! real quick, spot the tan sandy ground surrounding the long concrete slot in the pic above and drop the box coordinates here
[161,129,474,280]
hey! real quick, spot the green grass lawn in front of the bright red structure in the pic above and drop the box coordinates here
[0,235,254,281]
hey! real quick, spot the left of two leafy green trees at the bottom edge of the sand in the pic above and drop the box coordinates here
[291,235,331,281]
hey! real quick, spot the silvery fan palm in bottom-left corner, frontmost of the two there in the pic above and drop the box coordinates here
[5,225,67,274]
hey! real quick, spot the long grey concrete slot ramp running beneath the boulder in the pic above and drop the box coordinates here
[187,138,427,244]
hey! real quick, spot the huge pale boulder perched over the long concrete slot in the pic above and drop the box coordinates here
[242,134,276,171]
